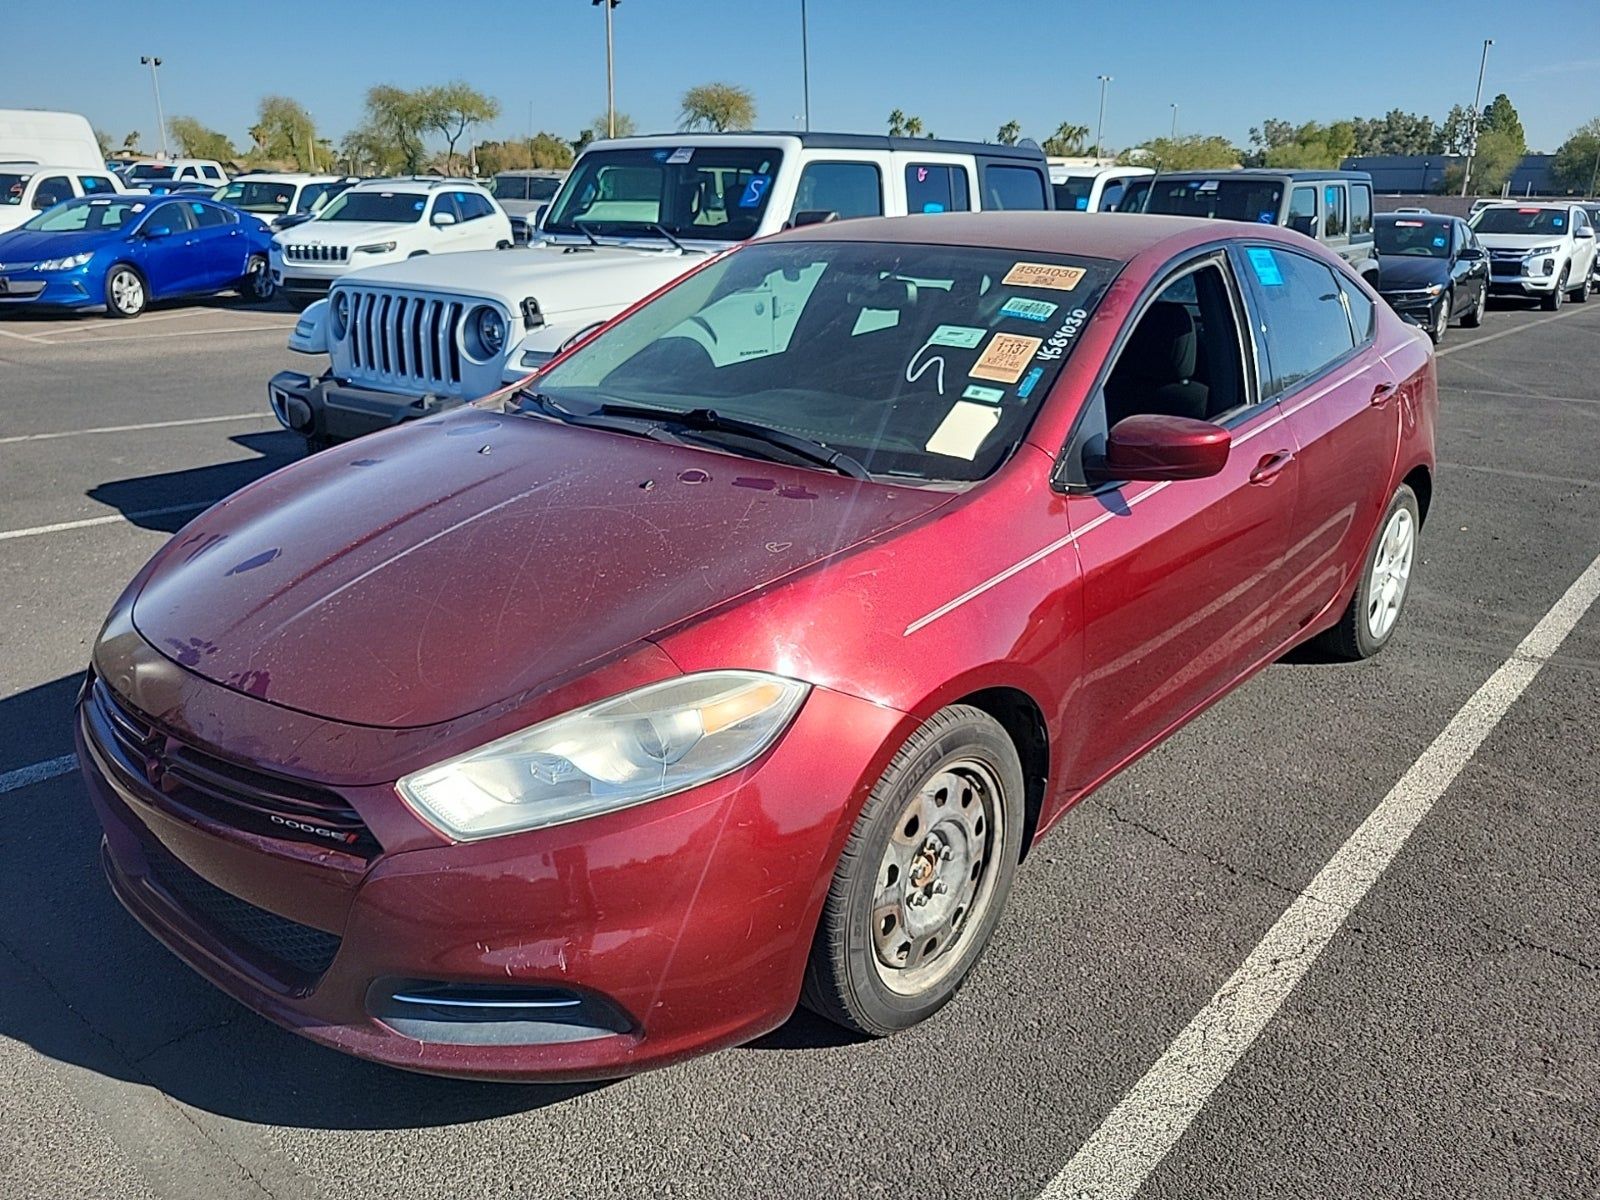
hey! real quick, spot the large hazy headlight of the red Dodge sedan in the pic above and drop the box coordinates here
[395,670,811,842]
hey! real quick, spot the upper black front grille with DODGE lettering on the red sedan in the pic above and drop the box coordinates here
[88,678,381,859]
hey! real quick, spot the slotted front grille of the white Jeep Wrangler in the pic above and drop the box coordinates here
[339,286,467,390]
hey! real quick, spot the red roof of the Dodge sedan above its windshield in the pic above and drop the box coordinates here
[762,211,1306,262]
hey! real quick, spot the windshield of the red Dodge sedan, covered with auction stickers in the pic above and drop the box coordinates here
[534,242,1118,483]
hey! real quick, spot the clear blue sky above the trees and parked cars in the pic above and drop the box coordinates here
[0,0,1600,149]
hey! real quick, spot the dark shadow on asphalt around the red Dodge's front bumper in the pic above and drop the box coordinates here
[0,675,602,1130]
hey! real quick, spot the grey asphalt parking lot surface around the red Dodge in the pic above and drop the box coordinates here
[0,299,1600,1200]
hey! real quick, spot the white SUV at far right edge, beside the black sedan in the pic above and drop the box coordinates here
[1467,203,1600,312]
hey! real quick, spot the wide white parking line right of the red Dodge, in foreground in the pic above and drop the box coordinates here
[1040,557,1600,1200]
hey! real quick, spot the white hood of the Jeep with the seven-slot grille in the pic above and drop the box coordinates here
[344,245,706,320]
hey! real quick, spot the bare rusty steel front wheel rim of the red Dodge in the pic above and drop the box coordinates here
[872,758,1006,995]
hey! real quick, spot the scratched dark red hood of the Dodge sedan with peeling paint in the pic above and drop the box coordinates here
[133,410,950,728]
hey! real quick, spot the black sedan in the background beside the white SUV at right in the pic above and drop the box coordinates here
[1374,213,1490,344]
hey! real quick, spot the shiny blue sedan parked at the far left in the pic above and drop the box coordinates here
[0,195,272,317]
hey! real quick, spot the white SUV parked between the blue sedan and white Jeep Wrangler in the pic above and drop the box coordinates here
[272,178,512,298]
